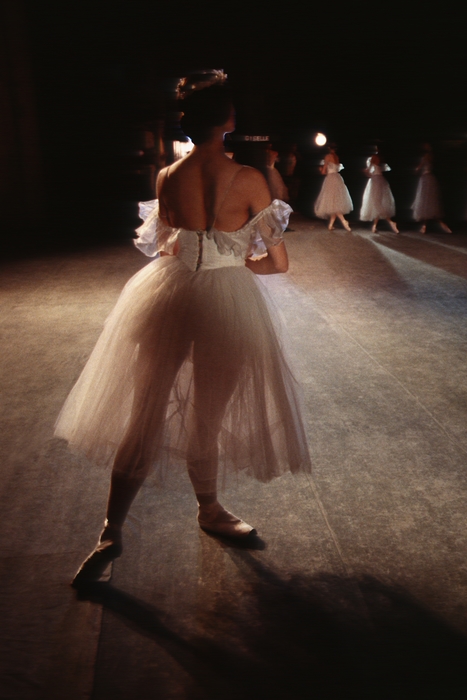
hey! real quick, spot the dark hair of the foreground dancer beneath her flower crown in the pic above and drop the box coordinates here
[180,85,233,144]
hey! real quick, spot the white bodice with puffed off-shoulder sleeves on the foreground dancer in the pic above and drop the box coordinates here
[135,199,292,271]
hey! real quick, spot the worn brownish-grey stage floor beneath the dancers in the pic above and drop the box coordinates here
[0,215,467,700]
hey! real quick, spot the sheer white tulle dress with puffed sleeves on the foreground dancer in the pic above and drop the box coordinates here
[56,200,311,492]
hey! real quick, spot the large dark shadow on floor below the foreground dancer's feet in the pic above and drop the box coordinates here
[75,550,467,700]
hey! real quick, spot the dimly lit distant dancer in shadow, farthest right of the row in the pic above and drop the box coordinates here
[412,143,452,233]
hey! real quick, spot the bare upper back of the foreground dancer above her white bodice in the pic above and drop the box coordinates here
[157,149,271,231]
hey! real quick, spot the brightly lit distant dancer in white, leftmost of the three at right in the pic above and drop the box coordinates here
[315,146,353,231]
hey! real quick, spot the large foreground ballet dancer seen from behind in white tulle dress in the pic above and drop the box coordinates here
[56,72,311,587]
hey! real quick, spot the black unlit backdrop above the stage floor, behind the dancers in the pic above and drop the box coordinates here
[1,0,467,252]
